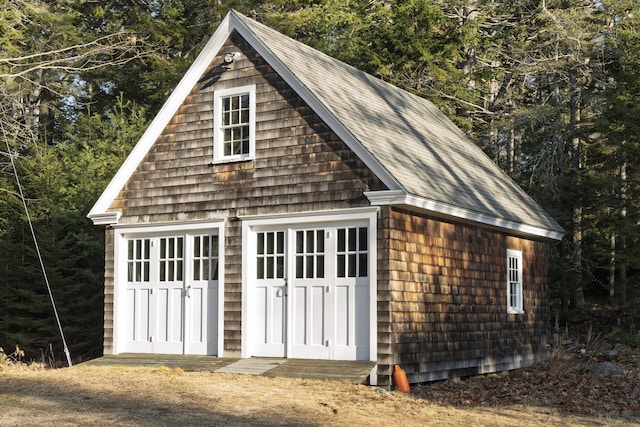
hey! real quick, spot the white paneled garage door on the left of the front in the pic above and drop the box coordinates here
[116,233,219,354]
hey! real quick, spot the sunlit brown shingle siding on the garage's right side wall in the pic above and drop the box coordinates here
[378,209,549,385]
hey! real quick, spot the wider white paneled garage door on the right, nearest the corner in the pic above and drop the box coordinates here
[247,225,371,360]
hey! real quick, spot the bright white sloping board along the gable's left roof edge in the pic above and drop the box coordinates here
[87,15,233,224]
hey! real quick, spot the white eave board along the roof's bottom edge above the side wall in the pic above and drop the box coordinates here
[364,190,564,240]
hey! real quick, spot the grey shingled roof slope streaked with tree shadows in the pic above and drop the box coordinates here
[231,12,562,237]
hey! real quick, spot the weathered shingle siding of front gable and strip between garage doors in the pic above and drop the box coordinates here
[105,34,384,357]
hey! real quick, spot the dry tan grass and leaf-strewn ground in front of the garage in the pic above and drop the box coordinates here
[0,350,640,426]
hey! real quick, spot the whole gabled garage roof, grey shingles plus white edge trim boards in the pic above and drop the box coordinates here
[89,11,564,240]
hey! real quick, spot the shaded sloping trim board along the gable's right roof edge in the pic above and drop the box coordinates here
[230,11,404,190]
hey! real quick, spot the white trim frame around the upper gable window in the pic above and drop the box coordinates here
[213,85,256,164]
